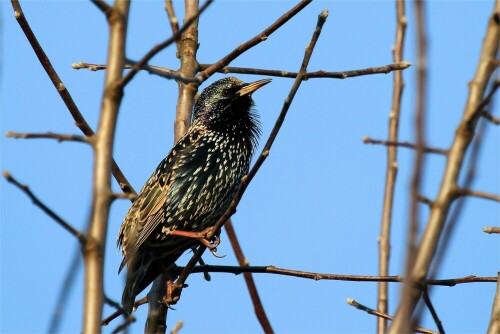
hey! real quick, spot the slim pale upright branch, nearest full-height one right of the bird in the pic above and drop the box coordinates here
[377,0,407,334]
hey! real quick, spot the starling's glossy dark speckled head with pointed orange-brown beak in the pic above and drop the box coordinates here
[193,77,271,133]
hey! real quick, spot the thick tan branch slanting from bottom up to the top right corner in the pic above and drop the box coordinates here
[389,0,500,333]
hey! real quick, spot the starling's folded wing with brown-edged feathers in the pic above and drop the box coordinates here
[118,129,205,270]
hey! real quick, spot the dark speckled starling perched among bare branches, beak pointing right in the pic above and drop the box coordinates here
[117,77,271,314]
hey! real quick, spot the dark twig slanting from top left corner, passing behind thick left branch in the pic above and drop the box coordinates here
[11,0,136,194]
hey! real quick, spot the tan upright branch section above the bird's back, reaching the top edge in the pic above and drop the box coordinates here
[174,0,199,142]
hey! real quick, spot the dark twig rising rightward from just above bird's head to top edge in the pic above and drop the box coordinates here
[196,0,312,82]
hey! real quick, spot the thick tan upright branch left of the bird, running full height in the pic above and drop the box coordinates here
[83,0,130,334]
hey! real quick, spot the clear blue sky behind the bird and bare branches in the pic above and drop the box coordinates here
[0,1,500,333]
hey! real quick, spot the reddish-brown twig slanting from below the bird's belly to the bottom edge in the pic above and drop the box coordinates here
[224,219,274,333]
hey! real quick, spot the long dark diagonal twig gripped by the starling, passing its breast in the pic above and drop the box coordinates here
[172,7,328,302]
